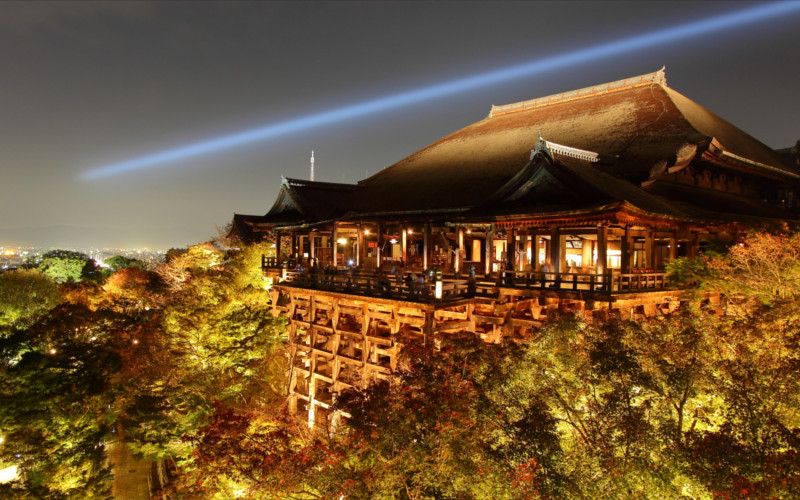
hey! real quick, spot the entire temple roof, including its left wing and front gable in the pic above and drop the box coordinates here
[236,70,800,229]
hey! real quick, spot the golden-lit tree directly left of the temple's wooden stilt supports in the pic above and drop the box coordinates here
[118,246,286,492]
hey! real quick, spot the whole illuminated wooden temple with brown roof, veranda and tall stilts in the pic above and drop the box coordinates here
[232,69,800,425]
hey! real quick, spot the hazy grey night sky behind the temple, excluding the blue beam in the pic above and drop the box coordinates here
[0,1,800,248]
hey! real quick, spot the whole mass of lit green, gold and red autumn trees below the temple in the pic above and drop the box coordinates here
[0,233,800,499]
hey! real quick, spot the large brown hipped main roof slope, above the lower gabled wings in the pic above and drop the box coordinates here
[359,68,792,211]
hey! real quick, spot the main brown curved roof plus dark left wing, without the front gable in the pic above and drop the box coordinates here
[239,68,800,232]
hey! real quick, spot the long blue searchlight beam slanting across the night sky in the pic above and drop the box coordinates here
[81,1,800,180]
